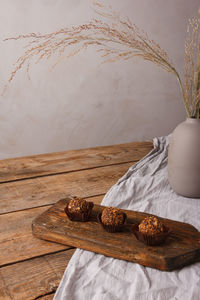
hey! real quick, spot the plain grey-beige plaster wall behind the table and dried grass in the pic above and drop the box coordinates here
[0,0,200,159]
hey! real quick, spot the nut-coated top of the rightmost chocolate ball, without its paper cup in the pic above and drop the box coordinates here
[139,216,164,235]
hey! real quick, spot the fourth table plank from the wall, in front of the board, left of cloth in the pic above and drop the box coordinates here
[0,249,75,300]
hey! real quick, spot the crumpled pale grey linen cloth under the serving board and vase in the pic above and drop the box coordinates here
[54,137,200,300]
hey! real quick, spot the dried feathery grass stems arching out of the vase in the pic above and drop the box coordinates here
[3,2,200,118]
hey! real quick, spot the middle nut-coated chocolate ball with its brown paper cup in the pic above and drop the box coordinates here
[98,207,126,232]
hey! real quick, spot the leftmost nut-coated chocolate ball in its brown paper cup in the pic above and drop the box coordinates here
[65,197,94,222]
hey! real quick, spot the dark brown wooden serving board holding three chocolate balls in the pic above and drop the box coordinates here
[32,198,200,271]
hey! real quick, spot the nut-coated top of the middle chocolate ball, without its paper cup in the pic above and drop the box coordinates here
[101,207,124,225]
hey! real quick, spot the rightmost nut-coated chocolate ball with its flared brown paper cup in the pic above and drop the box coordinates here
[131,216,170,246]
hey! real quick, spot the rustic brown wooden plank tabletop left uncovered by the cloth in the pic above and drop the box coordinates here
[0,142,153,300]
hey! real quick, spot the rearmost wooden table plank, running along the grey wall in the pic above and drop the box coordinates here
[0,142,152,182]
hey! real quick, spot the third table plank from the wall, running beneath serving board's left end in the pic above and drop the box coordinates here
[0,196,103,266]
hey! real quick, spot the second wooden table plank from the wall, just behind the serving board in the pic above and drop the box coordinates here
[0,163,132,214]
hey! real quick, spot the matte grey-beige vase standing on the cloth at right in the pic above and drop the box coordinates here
[168,118,200,198]
